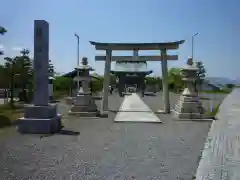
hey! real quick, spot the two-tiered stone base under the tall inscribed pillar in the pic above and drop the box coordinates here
[17,104,62,134]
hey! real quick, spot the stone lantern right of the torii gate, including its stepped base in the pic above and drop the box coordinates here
[173,58,206,120]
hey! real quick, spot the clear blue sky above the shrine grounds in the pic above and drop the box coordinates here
[0,0,240,79]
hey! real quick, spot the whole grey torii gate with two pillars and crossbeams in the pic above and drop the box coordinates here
[90,40,185,113]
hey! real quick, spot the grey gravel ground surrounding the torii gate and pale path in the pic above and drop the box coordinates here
[0,94,225,180]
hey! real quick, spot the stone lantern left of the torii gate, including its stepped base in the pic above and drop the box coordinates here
[69,58,99,116]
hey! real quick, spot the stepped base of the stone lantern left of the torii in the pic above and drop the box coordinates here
[69,93,99,117]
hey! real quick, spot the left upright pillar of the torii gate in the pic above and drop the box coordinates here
[100,49,112,115]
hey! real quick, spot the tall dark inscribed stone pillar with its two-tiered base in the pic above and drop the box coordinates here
[17,20,61,134]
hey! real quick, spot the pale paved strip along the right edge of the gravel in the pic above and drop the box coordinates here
[196,89,240,180]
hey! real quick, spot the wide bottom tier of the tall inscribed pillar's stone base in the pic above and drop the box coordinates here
[17,114,62,134]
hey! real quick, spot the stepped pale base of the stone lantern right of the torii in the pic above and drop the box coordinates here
[172,95,210,120]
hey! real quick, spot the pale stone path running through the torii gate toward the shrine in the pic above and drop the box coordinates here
[114,93,162,123]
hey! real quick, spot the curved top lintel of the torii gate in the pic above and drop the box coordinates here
[90,40,185,50]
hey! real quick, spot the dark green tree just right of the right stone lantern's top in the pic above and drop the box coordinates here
[195,61,206,92]
